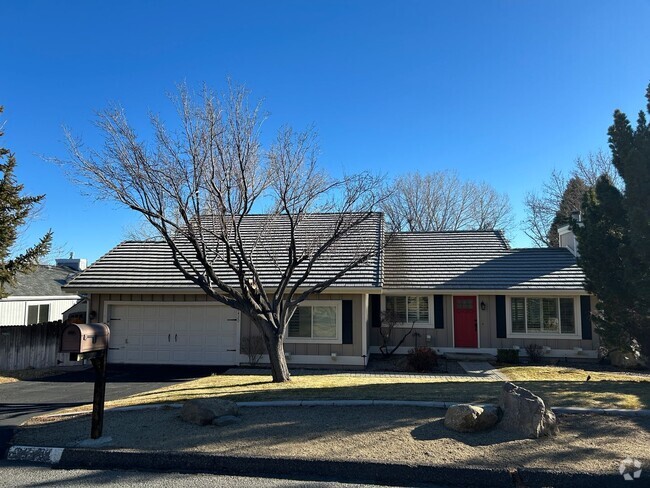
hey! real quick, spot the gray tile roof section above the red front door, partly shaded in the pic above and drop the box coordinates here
[384,231,584,291]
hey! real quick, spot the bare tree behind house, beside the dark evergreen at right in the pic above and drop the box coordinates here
[522,151,622,247]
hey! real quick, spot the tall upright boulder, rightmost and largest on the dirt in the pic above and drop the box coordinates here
[499,383,558,439]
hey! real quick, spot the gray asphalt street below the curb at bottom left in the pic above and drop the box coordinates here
[0,461,426,488]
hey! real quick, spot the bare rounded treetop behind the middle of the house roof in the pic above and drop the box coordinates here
[383,171,512,232]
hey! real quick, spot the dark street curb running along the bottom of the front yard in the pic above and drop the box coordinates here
[9,446,627,488]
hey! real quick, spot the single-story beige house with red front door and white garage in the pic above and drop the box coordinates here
[64,214,599,367]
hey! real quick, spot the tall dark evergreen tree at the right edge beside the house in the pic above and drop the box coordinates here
[575,85,650,355]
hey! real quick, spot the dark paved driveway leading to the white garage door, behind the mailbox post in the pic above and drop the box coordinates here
[0,365,227,459]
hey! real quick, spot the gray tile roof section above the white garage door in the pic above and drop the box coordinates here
[67,214,383,292]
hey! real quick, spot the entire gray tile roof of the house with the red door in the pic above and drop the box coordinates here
[66,214,584,292]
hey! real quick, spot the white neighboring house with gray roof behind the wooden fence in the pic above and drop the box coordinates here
[0,259,86,326]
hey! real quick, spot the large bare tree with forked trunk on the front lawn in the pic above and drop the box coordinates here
[59,86,385,382]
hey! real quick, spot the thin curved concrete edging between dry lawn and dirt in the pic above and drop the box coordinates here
[33,400,650,418]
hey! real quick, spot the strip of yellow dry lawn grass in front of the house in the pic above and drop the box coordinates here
[53,367,650,411]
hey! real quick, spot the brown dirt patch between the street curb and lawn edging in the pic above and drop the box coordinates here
[14,407,650,473]
